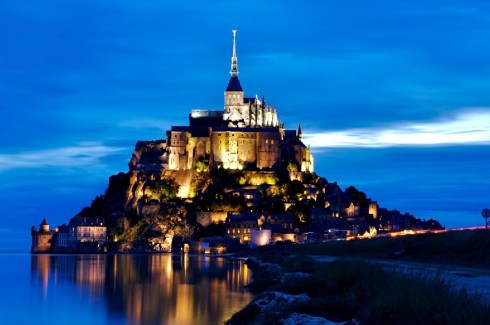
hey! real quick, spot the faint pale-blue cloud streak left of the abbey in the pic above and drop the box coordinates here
[0,142,128,172]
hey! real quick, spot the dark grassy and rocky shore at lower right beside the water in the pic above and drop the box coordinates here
[226,234,490,325]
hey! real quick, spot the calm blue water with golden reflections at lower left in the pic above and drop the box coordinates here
[0,254,252,325]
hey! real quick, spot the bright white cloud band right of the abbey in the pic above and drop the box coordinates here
[304,109,490,148]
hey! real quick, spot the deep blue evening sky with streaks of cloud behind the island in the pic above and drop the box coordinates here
[0,0,490,249]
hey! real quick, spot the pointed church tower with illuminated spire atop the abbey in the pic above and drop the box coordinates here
[223,30,248,127]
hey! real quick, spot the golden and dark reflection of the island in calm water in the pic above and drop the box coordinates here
[31,254,252,324]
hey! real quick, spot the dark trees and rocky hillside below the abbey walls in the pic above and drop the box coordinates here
[72,153,440,247]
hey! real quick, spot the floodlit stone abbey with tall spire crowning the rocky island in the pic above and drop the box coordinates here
[130,30,313,182]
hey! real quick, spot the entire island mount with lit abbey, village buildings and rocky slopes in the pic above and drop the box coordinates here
[31,30,441,253]
